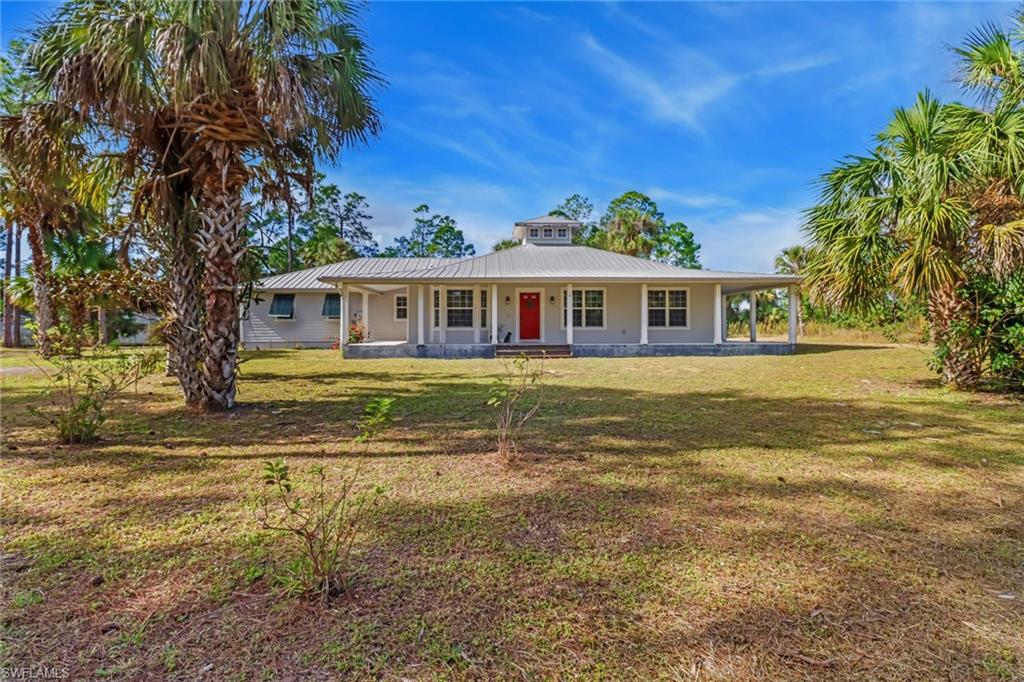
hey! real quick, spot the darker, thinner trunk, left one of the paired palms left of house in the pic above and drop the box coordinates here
[166,222,203,406]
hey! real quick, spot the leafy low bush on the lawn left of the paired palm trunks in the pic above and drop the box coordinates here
[37,346,161,443]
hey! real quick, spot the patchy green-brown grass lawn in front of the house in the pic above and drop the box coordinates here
[0,345,1024,680]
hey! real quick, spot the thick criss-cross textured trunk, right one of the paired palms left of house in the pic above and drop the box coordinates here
[199,143,247,410]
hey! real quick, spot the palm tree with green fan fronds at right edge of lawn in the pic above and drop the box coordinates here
[806,14,1024,387]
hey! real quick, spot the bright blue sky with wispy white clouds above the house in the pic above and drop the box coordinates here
[0,0,1015,270]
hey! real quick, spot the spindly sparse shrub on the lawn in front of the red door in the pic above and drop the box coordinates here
[487,355,544,463]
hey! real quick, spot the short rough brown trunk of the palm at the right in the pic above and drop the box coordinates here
[928,286,981,390]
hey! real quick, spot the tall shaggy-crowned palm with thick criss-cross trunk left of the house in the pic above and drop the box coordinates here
[34,0,381,409]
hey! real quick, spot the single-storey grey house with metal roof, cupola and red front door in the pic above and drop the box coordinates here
[242,215,800,357]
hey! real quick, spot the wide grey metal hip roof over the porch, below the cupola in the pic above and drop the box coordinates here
[315,244,801,286]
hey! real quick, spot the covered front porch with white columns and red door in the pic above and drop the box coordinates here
[338,282,798,357]
